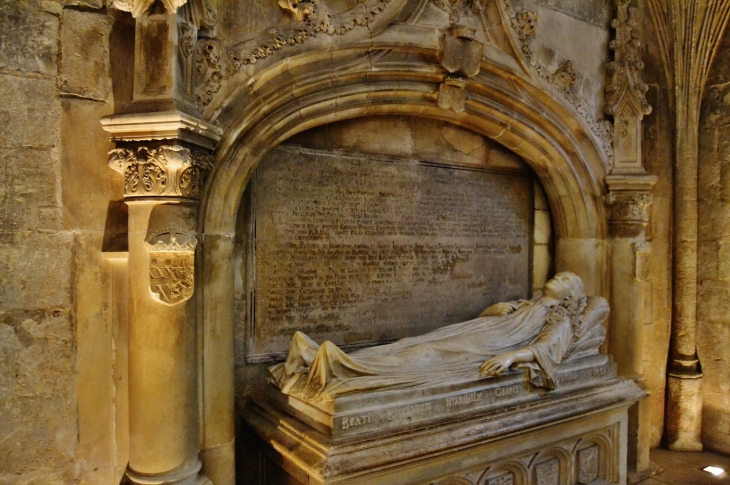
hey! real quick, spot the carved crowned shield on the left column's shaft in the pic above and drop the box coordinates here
[145,230,198,305]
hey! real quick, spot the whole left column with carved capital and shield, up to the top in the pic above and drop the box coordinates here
[102,0,221,485]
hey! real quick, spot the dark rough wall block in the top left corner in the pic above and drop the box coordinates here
[0,0,59,76]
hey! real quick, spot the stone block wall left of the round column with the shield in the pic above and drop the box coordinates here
[0,0,129,485]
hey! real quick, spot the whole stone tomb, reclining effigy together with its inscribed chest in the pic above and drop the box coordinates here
[245,286,644,485]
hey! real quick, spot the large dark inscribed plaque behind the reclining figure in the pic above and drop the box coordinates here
[247,146,533,362]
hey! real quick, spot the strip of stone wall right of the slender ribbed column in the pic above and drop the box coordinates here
[697,29,730,453]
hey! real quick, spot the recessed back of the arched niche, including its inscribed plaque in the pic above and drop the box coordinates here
[233,116,554,366]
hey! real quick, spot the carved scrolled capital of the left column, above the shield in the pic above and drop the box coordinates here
[109,145,213,198]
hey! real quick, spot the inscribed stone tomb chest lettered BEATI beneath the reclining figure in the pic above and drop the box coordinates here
[243,356,644,485]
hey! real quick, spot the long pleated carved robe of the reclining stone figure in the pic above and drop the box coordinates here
[269,299,608,401]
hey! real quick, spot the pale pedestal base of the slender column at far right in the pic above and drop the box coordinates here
[666,373,702,451]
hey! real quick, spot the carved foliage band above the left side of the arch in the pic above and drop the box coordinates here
[195,0,393,110]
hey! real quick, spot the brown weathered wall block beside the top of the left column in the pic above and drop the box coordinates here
[59,9,112,101]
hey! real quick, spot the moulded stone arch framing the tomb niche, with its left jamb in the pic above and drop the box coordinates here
[198,42,607,480]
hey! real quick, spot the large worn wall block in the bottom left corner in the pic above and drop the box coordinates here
[0,309,76,484]
